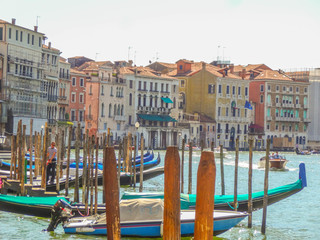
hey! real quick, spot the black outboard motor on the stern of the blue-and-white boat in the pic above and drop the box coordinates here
[47,199,73,232]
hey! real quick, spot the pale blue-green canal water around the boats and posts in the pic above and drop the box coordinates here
[0,151,320,240]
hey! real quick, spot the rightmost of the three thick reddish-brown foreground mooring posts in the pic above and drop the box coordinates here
[194,151,216,240]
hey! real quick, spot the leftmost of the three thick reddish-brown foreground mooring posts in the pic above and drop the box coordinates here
[103,146,121,240]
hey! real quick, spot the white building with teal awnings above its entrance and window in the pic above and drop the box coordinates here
[120,67,182,149]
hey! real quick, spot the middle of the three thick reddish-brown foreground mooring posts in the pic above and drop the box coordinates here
[163,146,181,240]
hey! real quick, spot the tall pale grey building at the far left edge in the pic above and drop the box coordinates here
[0,19,47,134]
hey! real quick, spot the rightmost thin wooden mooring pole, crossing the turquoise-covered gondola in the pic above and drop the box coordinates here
[261,139,271,234]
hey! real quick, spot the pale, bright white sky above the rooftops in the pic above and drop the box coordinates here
[0,0,320,70]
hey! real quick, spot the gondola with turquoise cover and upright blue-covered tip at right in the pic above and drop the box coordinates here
[122,163,307,211]
